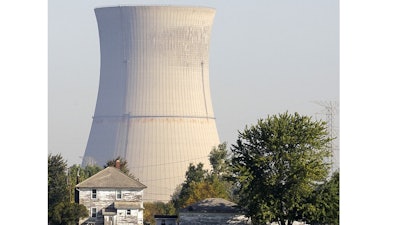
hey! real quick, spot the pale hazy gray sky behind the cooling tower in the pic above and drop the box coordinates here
[48,0,339,165]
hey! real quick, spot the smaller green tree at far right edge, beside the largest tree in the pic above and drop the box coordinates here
[305,171,339,225]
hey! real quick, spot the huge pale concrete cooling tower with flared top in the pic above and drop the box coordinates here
[82,6,219,201]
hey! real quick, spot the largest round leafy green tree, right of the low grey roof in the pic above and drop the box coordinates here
[231,112,331,225]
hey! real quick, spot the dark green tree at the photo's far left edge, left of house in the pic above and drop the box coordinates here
[47,154,69,221]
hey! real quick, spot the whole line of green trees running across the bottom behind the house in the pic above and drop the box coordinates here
[49,112,339,225]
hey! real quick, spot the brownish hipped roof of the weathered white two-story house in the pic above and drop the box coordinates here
[75,166,147,190]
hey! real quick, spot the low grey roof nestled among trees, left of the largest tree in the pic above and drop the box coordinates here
[180,198,241,213]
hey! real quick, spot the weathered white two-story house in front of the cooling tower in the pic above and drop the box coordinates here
[75,164,146,225]
